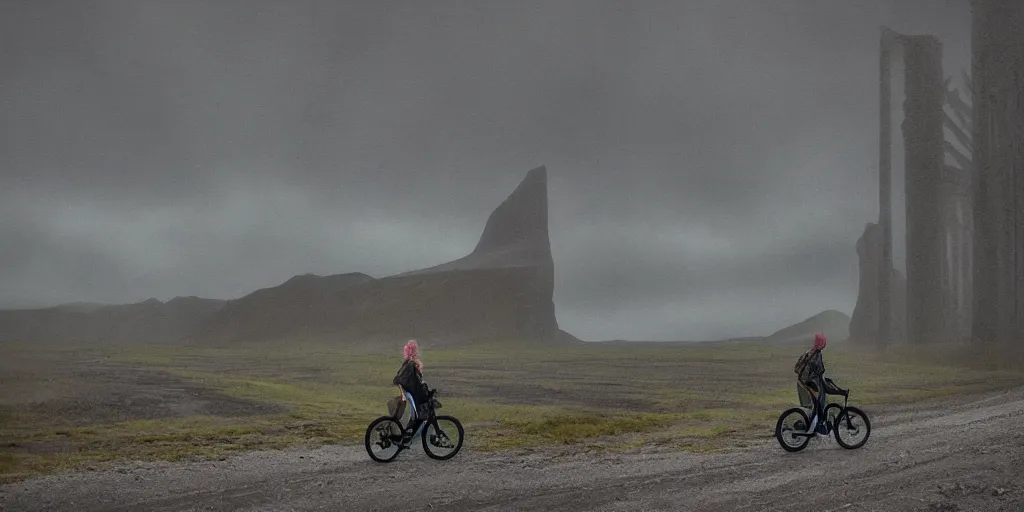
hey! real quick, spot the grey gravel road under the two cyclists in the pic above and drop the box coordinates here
[0,388,1024,512]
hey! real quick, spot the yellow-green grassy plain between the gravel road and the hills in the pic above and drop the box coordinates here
[0,337,1021,481]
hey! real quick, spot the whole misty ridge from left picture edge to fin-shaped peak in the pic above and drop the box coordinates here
[0,167,579,345]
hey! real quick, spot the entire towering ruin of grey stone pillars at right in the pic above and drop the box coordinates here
[864,0,1024,345]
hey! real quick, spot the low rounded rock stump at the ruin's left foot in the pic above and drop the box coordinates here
[850,223,906,344]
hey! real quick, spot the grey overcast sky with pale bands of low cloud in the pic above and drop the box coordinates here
[0,0,970,340]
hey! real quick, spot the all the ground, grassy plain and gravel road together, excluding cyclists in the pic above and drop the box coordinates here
[0,342,1024,512]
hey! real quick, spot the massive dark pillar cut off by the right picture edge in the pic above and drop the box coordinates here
[971,0,1024,344]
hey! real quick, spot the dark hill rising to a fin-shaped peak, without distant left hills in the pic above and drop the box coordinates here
[193,167,579,346]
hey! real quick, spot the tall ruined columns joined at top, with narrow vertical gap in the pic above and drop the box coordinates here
[872,28,958,344]
